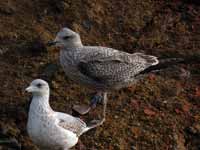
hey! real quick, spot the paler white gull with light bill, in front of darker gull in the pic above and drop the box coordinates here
[26,79,102,150]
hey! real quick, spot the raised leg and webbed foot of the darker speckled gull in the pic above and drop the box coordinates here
[72,92,103,115]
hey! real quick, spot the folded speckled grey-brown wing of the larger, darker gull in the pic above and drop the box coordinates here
[78,47,158,85]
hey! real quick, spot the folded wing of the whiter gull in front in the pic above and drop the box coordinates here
[55,112,87,136]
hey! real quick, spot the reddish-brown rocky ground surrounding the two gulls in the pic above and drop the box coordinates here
[0,0,200,150]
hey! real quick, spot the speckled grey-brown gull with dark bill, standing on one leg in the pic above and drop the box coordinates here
[49,28,159,118]
